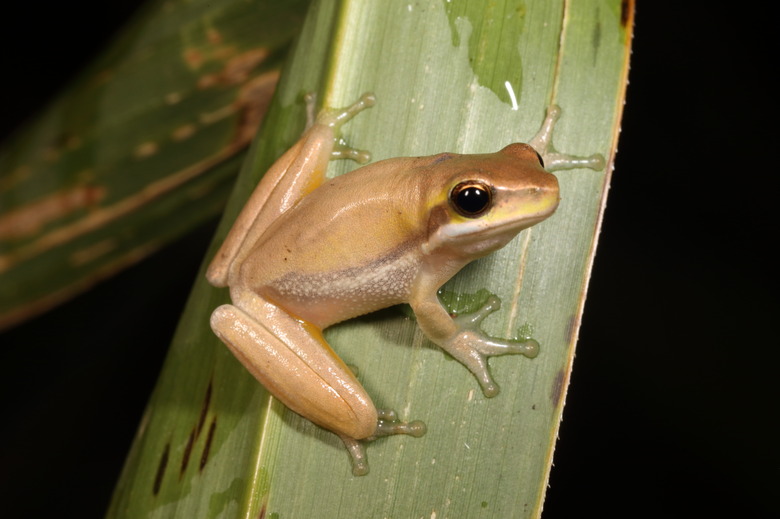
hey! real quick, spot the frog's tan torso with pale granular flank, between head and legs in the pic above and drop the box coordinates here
[239,160,424,327]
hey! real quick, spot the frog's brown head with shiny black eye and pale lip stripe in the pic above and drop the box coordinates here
[425,144,559,258]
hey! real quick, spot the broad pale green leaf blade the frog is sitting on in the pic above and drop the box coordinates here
[109,0,633,518]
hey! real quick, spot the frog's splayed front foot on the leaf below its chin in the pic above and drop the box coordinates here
[441,296,539,397]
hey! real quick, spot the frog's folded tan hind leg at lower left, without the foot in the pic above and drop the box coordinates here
[211,296,377,439]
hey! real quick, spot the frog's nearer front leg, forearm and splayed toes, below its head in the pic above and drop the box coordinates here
[410,286,539,397]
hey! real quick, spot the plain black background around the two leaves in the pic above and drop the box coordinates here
[0,0,780,519]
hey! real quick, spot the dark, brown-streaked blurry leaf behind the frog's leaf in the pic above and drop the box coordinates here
[0,0,309,328]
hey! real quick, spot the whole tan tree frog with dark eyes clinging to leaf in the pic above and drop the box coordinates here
[207,94,604,475]
